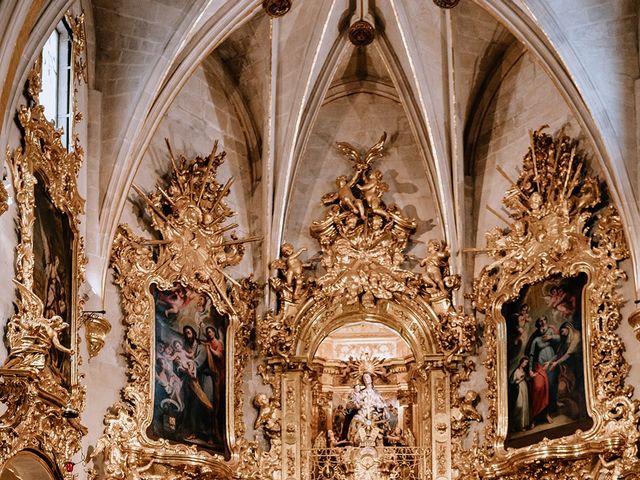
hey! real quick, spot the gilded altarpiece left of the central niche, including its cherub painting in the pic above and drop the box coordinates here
[93,142,273,480]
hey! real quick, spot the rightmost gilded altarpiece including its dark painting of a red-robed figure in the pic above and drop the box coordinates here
[468,130,639,480]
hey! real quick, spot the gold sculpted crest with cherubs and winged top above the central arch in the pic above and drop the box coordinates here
[259,134,475,364]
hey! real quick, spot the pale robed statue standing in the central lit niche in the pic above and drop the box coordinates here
[347,372,391,447]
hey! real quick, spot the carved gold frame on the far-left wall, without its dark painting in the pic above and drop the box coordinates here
[0,12,86,477]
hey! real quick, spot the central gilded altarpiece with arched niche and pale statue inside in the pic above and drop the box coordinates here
[254,135,480,480]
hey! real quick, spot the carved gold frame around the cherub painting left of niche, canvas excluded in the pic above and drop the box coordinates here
[94,142,266,479]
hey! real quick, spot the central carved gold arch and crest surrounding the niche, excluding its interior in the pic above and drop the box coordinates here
[254,134,478,479]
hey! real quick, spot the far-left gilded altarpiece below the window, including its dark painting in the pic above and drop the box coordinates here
[0,13,86,478]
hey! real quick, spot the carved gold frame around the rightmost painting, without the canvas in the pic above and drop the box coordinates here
[463,125,639,479]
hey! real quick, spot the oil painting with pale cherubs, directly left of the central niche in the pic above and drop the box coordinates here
[151,284,228,454]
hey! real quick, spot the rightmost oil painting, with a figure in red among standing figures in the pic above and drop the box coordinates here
[502,273,592,447]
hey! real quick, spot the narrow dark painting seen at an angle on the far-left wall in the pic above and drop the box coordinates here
[33,178,74,388]
